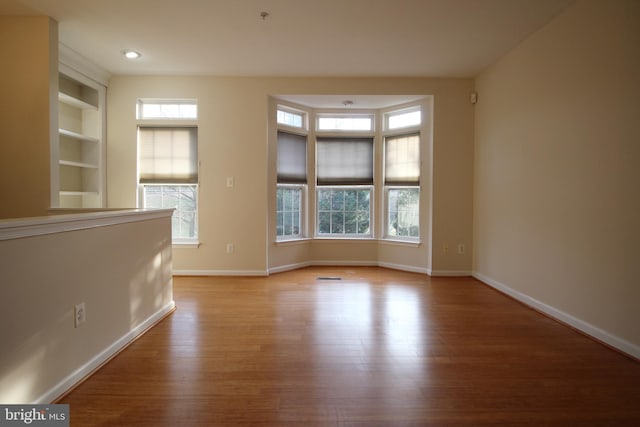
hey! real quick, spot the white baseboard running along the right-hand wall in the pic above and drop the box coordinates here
[473,271,640,359]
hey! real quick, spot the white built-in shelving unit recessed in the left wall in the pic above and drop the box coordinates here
[52,64,106,208]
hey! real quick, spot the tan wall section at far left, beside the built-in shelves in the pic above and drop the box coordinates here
[0,16,58,218]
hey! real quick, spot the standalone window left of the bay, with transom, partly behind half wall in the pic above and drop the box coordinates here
[138,100,198,244]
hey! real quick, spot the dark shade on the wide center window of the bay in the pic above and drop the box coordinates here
[316,138,373,185]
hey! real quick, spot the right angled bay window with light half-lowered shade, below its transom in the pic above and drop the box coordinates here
[384,133,420,240]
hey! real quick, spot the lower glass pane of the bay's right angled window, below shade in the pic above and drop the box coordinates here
[387,188,420,238]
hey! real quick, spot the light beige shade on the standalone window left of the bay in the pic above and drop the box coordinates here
[138,126,198,184]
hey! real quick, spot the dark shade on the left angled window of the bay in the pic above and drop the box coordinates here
[278,131,307,184]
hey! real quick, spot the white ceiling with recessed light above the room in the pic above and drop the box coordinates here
[0,0,571,77]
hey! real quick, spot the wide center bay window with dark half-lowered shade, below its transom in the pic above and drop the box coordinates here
[316,137,373,237]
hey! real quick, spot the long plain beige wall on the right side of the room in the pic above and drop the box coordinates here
[473,0,640,357]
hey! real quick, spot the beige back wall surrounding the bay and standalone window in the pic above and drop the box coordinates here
[107,76,473,274]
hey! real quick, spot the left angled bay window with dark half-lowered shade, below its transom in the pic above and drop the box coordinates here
[276,131,307,240]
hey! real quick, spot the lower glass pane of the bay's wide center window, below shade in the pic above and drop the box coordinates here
[318,188,371,236]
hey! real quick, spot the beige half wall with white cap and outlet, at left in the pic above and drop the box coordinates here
[0,211,173,403]
